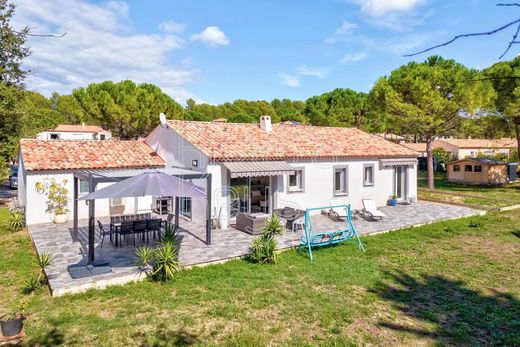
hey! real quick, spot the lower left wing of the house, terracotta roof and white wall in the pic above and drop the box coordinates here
[18,139,164,225]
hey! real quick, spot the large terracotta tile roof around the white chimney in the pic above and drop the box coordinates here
[168,120,417,161]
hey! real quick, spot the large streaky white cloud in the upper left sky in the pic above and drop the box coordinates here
[14,0,199,102]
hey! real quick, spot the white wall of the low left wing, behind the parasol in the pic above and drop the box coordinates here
[19,171,152,225]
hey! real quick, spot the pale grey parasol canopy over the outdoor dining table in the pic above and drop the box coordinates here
[78,171,206,200]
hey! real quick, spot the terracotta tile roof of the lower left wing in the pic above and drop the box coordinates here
[20,139,164,171]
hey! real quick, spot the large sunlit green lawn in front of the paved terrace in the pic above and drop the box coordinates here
[0,211,520,346]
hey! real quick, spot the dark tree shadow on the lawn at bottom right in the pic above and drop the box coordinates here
[373,272,520,345]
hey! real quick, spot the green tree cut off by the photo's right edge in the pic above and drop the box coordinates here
[484,57,520,161]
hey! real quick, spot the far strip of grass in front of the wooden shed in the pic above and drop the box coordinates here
[417,172,520,208]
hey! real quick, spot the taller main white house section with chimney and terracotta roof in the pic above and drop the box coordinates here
[145,116,417,231]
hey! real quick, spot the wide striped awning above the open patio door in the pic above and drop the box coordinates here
[223,161,294,178]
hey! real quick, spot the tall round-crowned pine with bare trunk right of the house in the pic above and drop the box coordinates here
[371,56,494,189]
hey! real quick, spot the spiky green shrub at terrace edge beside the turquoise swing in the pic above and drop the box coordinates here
[250,215,285,264]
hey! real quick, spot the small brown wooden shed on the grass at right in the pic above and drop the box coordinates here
[446,158,508,185]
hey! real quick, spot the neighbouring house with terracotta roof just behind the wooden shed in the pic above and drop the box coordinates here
[433,138,517,159]
